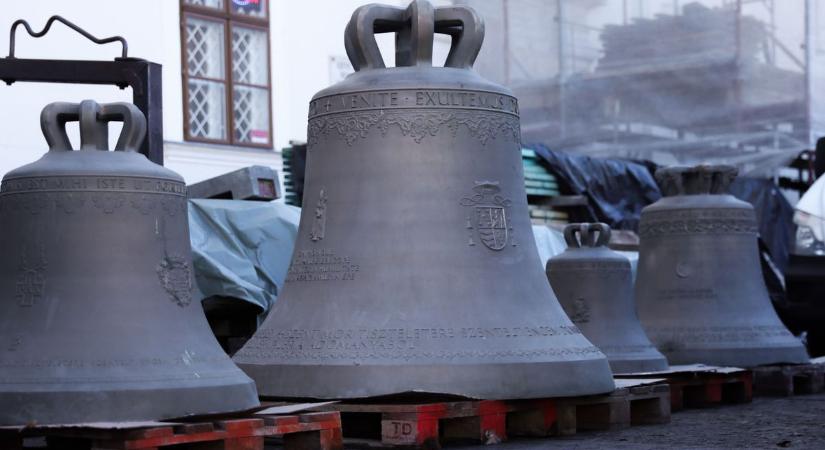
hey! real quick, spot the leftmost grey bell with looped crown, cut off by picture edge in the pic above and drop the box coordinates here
[0,100,258,425]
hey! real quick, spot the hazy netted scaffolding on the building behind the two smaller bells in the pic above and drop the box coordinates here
[456,0,825,175]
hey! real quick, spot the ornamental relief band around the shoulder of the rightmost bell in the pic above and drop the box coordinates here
[639,209,759,237]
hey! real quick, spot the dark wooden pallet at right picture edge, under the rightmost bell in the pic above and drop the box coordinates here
[753,358,825,397]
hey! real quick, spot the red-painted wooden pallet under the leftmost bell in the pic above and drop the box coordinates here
[0,412,343,450]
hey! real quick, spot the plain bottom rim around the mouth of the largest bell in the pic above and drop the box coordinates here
[236,353,615,400]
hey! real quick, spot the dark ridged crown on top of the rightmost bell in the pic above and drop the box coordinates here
[656,165,739,197]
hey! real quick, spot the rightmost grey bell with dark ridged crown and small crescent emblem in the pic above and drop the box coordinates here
[636,166,808,367]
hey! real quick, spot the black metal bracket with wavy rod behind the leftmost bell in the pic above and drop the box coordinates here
[0,16,163,165]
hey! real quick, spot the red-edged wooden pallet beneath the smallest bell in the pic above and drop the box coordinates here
[616,364,753,411]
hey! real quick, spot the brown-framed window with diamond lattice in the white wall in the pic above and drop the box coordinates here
[181,0,272,147]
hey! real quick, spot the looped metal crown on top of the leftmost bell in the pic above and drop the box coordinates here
[40,100,146,152]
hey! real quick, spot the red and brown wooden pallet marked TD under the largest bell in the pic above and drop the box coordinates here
[302,380,670,448]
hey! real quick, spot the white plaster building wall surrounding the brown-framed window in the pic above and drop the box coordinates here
[0,0,450,183]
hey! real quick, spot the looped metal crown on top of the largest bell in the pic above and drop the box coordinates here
[344,0,484,72]
